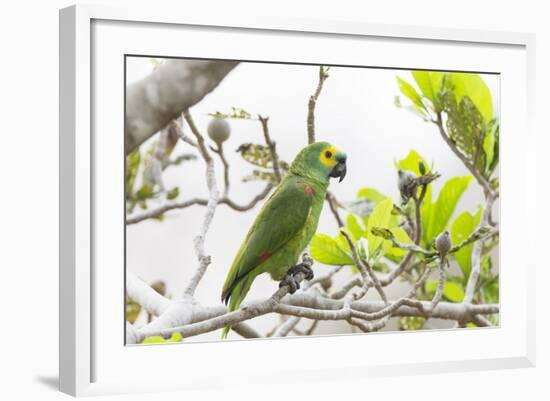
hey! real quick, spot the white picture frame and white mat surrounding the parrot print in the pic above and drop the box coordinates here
[59,5,535,396]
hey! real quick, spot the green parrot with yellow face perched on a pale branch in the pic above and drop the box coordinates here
[222,142,346,338]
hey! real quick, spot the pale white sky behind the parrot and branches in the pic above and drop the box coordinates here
[126,58,499,340]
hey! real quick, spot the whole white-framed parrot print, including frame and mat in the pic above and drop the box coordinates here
[60,6,534,395]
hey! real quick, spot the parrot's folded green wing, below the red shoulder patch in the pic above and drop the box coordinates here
[222,174,313,309]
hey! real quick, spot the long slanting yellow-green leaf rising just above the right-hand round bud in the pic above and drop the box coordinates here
[424,176,473,243]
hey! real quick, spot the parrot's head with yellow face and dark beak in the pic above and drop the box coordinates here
[290,142,347,183]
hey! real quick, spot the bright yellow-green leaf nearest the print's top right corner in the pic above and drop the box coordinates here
[450,72,493,123]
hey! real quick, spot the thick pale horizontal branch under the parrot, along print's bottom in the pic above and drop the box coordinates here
[127,247,499,343]
